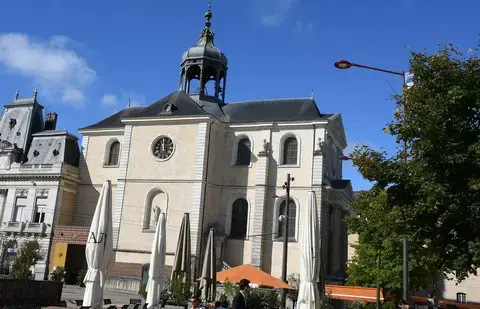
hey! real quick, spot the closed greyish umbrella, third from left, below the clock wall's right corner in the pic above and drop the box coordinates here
[171,213,192,288]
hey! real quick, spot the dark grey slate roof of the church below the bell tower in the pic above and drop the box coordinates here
[80,90,333,130]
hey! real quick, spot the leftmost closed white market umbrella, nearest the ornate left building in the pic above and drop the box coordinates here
[83,180,113,309]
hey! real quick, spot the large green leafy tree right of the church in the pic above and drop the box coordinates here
[348,39,480,296]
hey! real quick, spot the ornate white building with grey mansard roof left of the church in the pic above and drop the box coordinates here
[0,91,80,280]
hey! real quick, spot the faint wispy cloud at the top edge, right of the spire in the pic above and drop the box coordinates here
[255,0,299,27]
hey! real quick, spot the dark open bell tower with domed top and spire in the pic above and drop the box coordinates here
[179,4,228,105]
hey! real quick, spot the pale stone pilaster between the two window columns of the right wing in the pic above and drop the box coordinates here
[251,140,270,268]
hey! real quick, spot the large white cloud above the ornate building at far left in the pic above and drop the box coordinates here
[0,33,97,106]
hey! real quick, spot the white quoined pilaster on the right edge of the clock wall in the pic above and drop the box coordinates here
[190,122,210,256]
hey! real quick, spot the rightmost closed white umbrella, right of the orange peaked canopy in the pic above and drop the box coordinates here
[297,191,321,309]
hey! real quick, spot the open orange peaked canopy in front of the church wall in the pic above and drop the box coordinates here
[217,264,294,290]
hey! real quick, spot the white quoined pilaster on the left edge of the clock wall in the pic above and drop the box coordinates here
[112,125,133,249]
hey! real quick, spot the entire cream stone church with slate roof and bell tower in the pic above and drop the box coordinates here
[73,6,353,283]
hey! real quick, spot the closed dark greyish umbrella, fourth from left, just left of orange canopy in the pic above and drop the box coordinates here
[200,229,217,302]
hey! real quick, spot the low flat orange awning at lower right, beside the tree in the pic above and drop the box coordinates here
[325,285,384,303]
